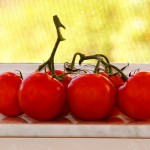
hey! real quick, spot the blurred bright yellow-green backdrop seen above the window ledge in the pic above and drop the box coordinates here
[0,0,150,63]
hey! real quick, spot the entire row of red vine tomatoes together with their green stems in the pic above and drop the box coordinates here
[0,16,150,121]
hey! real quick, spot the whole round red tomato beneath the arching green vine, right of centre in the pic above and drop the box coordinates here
[68,74,116,120]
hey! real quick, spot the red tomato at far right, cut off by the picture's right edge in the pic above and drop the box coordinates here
[117,72,150,120]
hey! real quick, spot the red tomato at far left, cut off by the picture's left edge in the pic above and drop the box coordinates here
[0,72,23,117]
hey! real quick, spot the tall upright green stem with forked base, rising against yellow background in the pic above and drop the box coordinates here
[36,15,66,78]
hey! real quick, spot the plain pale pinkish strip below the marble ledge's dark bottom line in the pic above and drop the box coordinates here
[0,138,150,150]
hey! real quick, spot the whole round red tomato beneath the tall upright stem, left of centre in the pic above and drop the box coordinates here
[19,72,65,121]
